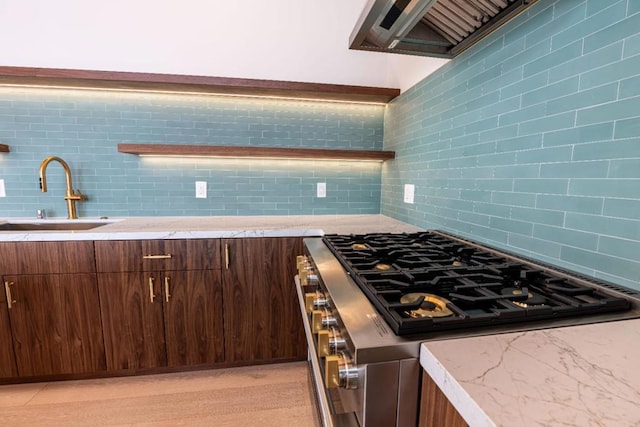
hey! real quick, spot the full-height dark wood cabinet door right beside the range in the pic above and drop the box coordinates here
[223,238,306,362]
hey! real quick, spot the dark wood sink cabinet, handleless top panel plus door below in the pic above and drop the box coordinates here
[0,242,106,377]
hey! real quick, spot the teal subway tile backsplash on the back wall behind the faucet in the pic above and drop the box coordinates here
[0,88,384,217]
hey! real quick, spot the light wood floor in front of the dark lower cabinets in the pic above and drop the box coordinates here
[0,362,317,427]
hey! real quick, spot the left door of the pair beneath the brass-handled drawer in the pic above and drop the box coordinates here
[98,272,167,371]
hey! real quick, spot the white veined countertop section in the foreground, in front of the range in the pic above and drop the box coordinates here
[420,319,640,427]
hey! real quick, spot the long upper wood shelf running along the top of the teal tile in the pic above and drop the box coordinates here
[0,67,400,104]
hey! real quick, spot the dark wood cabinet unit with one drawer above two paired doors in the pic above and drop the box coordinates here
[96,239,224,371]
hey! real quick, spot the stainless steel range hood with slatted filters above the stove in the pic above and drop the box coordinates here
[349,0,536,58]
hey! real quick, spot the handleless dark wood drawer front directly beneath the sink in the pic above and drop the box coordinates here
[0,241,95,274]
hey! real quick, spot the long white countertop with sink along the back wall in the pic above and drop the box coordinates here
[0,215,422,242]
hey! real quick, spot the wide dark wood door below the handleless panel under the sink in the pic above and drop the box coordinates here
[5,274,105,376]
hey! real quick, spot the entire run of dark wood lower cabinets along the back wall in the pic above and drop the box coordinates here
[0,234,307,382]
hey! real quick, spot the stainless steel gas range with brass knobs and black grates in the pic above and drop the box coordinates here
[296,231,640,427]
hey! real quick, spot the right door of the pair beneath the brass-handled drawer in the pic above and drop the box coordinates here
[162,270,224,366]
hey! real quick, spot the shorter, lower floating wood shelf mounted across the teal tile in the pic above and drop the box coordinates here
[118,144,395,161]
